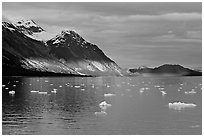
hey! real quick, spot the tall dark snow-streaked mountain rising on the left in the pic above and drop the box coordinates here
[2,20,122,76]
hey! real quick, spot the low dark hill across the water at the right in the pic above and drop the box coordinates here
[129,64,202,76]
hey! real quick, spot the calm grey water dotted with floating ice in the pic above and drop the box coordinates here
[2,76,202,135]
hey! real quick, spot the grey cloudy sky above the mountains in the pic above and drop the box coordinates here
[2,2,202,68]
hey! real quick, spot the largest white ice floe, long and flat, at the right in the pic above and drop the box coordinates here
[169,102,196,110]
